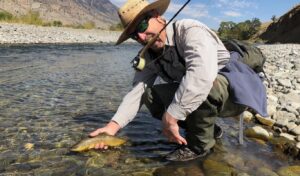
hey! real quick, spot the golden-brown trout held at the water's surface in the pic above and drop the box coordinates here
[71,133,126,152]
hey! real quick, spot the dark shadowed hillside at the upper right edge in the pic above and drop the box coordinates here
[259,4,300,43]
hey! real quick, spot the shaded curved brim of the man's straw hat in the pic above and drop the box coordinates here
[116,0,170,45]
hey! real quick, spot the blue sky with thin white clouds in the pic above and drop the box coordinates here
[110,0,300,30]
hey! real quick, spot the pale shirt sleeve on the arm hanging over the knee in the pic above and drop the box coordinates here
[167,26,218,120]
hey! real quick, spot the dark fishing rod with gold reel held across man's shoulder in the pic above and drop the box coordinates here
[131,0,191,71]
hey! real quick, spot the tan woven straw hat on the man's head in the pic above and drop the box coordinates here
[116,0,170,45]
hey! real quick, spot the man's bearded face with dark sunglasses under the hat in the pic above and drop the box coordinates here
[133,16,166,51]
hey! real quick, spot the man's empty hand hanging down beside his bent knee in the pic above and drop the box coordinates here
[162,112,187,145]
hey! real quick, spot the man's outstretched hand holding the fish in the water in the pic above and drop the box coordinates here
[89,121,120,149]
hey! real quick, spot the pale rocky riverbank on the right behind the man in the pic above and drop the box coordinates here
[244,44,300,159]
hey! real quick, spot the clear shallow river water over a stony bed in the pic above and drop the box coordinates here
[0,45,299,175]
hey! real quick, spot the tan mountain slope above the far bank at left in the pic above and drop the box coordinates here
[0,0,119,29]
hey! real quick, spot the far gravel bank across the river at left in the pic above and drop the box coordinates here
[0,23,127,44]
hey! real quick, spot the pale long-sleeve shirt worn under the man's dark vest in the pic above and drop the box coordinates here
[112,20,230,127]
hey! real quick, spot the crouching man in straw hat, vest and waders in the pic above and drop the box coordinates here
[90,0,266,161]
